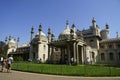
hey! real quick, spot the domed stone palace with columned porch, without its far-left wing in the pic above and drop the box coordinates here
[5,18,120,64]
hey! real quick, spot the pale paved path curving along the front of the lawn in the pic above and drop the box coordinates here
[0,66,120,80]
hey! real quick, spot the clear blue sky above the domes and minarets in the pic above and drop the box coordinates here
[0,0,120,43]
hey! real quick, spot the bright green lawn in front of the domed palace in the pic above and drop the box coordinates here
[12,62,120,76]
